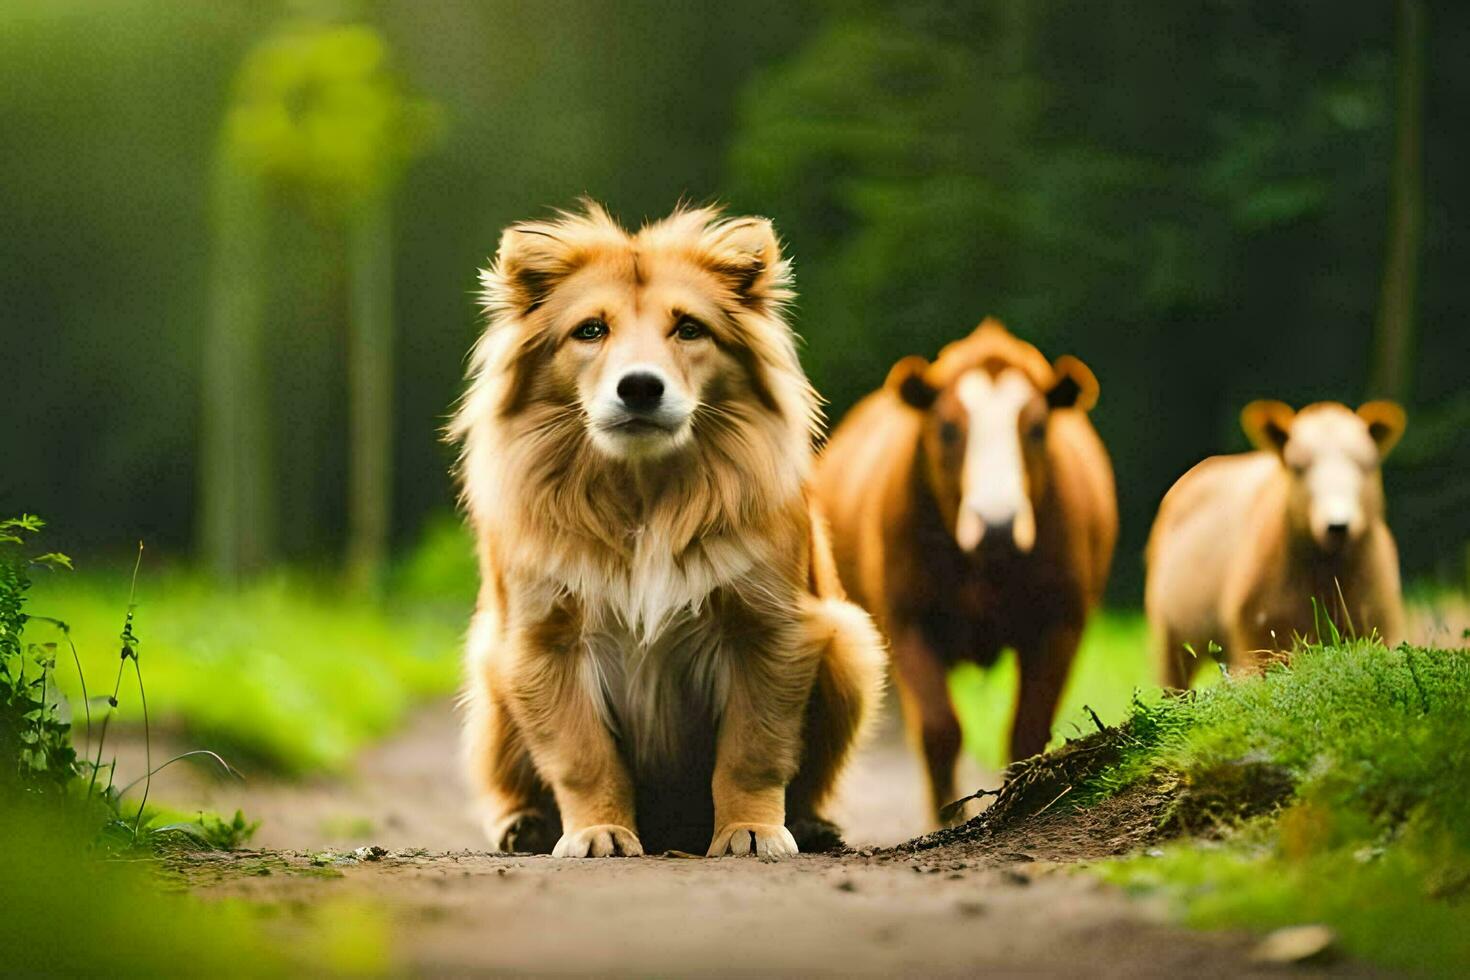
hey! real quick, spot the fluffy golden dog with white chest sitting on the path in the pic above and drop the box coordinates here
[451,204,883,857]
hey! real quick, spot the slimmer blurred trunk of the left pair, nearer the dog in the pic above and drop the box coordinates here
[347,195,392,592]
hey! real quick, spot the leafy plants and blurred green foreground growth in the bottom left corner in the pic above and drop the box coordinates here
[0,516,388,977]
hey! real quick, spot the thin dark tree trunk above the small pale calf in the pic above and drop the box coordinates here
[1370,0,1429,401]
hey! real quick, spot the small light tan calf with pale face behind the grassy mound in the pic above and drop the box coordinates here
[1145,401,1404,688]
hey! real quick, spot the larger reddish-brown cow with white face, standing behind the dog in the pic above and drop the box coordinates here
[816,319,1117,814]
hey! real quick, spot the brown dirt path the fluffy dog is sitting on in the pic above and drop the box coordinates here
[119,705,1366,977]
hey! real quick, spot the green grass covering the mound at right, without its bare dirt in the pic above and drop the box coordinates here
[1094,642,1470,976]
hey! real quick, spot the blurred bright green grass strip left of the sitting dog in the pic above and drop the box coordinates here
[29,566,469,774]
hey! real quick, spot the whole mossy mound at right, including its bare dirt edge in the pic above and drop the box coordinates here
[913,641,1470,976]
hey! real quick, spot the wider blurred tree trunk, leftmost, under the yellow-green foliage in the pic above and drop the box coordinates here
[198,150,276,582]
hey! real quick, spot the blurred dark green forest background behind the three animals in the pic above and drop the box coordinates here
[0,0,1470,605]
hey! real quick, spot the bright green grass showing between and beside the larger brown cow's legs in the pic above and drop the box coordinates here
[950,610,1217,770]
